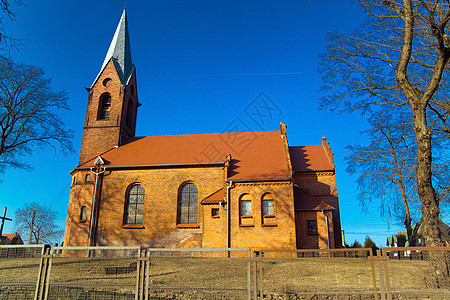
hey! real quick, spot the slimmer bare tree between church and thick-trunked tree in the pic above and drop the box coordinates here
[345,111,421,241]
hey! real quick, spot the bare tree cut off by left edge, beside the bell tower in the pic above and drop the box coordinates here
[0,59,73,174]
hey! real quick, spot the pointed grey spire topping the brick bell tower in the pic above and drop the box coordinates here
[92,8,134,86]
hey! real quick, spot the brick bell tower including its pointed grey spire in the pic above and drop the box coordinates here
[79,9,140,164]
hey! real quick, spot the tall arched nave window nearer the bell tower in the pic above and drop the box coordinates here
[124,184,145,224]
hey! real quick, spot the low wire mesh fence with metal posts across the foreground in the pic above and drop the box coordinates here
[0,245,450,300]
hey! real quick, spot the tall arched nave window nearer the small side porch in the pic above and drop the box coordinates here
[178,182,198,224]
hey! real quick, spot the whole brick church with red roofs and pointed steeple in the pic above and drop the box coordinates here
[64,10,342,249]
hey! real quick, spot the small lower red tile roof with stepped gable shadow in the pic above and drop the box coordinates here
[289,145,334,171]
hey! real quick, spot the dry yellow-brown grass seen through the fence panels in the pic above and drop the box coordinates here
[0,256,442,292]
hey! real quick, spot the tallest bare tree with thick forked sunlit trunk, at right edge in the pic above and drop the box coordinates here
[320,0,450,246]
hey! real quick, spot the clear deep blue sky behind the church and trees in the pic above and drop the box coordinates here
[0,0,400,246]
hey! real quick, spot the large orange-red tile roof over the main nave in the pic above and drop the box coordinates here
[79,130,290,180]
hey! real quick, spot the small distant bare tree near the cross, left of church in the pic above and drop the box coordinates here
[15,202,62,244]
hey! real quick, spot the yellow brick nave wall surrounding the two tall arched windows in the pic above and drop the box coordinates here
[66,167,223,247]
